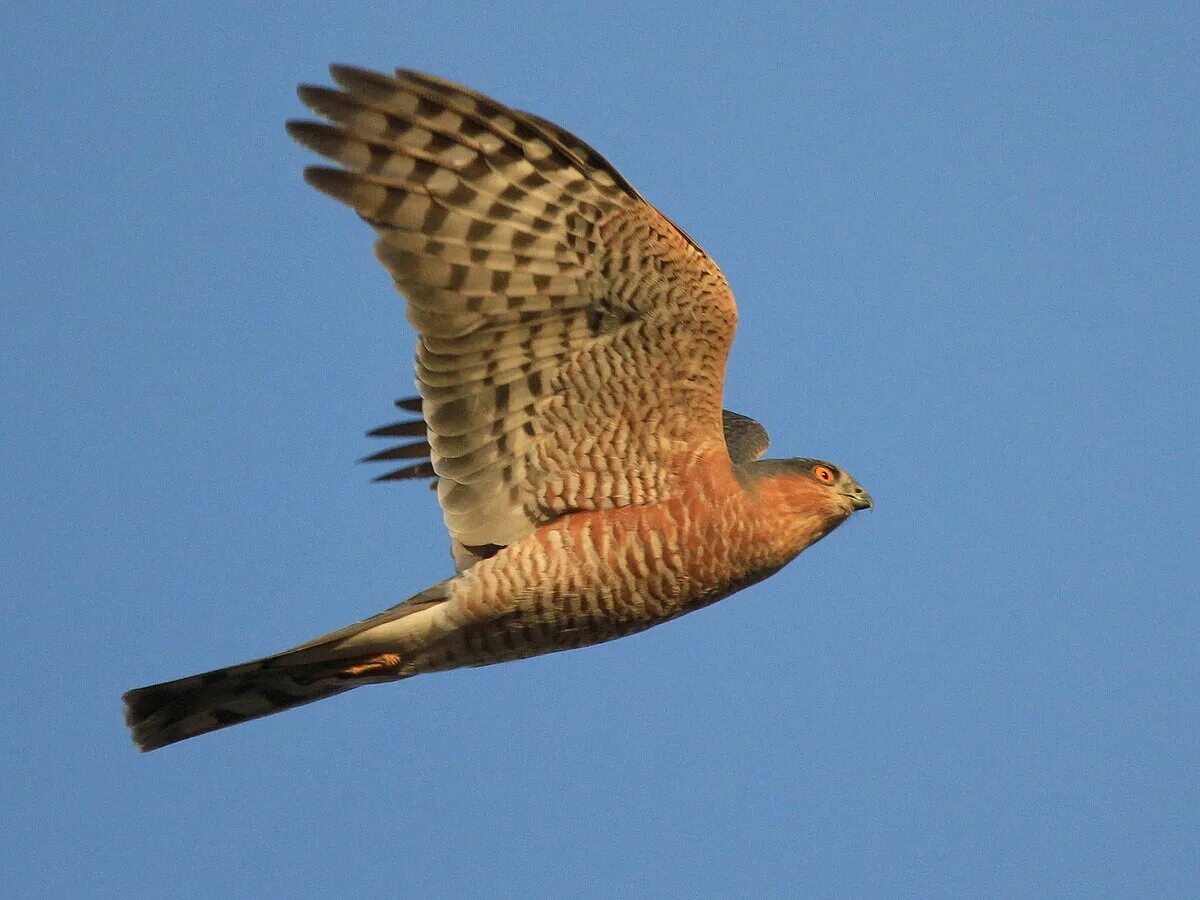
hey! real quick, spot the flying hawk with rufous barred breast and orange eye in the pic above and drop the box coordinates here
[125,66,872,750]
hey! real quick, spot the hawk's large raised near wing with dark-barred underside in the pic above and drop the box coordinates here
[288,66,737,547]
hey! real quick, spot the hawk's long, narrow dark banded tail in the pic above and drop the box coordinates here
[122,582,449,751]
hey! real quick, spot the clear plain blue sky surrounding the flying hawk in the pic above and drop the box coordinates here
[0,1,1200,898]
